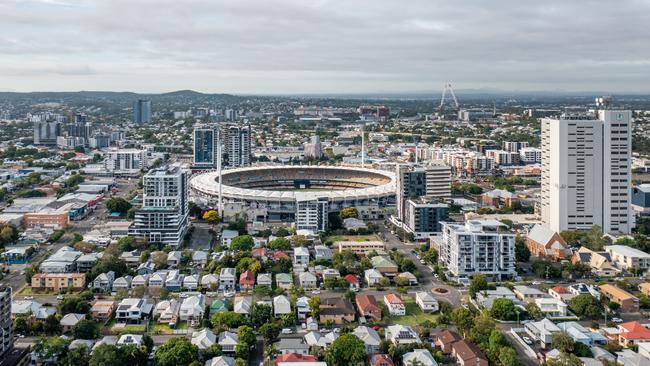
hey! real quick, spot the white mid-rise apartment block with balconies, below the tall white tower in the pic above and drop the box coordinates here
[437,220,516,280]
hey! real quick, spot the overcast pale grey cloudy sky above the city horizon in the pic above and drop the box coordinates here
[0,0,650,94]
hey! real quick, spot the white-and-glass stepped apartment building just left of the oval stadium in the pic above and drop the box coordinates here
[129,165,189,246]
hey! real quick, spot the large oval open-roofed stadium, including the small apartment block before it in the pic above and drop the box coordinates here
[189,166,396,231]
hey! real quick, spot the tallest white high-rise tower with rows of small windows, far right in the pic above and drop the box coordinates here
[541,109,634,233]
